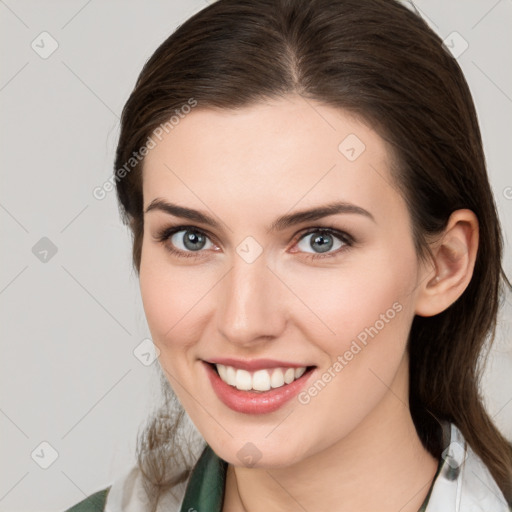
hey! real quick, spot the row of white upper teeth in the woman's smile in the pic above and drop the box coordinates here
[215,364,306,391]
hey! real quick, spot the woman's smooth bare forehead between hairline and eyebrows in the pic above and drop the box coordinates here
[143,97,403,224]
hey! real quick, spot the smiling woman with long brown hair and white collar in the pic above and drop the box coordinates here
[64,0,512,512]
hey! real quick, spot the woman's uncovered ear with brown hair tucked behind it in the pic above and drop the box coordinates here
[415,209,479,316]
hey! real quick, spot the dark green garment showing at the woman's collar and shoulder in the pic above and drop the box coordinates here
[66,445,442,512]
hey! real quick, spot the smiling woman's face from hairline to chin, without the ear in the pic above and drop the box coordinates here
[140,96,425,467]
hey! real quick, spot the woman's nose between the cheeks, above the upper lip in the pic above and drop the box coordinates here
[217,253,287,348]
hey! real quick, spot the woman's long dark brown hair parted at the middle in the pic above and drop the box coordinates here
[115,0,512,502]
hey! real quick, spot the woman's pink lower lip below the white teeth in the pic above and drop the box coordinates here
[203,362,314,414]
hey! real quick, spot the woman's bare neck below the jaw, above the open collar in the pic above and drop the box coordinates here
[223,356,438,512]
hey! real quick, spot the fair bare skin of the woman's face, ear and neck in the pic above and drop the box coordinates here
[140,96,478,512]
